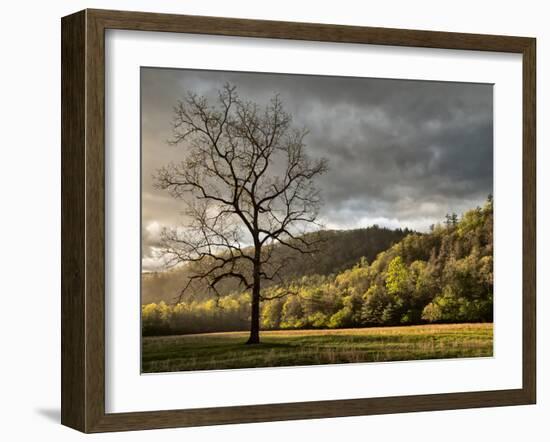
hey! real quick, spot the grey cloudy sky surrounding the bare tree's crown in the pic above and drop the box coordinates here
[141,68,493,270]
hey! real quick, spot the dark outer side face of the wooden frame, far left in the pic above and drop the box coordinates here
[61,12,86,429]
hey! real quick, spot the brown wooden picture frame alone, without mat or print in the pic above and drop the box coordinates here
[61,10,536,433]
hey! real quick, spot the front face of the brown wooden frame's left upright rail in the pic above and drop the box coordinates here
[85,11,105,431]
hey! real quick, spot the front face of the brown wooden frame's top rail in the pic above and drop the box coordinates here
[88,10,530,52]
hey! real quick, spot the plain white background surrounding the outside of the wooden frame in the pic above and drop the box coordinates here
[0,0,550,442]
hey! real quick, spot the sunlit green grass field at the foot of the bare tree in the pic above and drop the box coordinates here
[142,324,493,373]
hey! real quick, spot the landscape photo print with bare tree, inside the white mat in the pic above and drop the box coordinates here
[140,67,493,373]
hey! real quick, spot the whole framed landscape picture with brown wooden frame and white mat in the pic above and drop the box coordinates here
[61,10,536,432]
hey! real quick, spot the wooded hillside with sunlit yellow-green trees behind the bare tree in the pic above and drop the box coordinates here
[142,198,493,335]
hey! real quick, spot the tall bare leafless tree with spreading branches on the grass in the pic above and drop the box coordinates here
[155,84,327,344]
